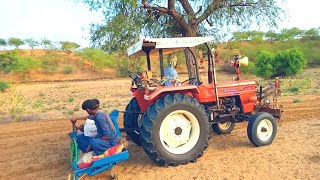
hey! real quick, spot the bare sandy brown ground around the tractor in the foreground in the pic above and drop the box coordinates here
[0,96,320,179]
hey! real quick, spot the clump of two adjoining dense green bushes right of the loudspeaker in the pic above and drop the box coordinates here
[255,49,307,78]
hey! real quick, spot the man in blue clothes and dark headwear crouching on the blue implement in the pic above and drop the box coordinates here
[70,99,117,155]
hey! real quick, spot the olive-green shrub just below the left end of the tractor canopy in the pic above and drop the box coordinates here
[116,56,144,77]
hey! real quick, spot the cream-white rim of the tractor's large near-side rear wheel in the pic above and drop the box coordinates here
[159,110,200,154]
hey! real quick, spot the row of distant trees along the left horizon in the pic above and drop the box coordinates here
[0,37,80,51]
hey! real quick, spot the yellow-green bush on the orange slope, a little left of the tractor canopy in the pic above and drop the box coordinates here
[79,48,116,69]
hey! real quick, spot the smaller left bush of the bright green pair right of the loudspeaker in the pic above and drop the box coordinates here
[255,51,275,78]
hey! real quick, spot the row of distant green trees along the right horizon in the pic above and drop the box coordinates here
[231,27,320,41]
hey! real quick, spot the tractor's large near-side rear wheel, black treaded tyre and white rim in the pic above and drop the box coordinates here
[140,94,210,166]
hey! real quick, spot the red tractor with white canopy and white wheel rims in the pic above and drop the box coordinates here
[122,37,282,166]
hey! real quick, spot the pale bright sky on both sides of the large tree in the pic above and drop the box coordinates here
[0,0,320,47]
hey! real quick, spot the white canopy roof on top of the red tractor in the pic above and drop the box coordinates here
[127,37,214,56]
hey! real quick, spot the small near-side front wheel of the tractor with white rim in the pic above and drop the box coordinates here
[247,112,277,147]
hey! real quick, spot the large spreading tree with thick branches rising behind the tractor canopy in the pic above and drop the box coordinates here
[81,0,283,77]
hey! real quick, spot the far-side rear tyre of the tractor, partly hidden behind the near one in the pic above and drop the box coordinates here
[123,98,141,146]
